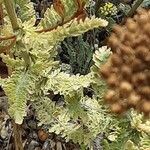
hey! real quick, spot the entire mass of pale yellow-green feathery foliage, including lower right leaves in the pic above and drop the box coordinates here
[0,0,150,150]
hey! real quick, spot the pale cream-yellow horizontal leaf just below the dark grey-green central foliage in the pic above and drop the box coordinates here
[46,70,91,95]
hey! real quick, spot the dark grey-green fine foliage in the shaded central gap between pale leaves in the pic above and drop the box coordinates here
[61,35,94,75]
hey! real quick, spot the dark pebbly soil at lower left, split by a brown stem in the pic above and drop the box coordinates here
[0,96,80,150]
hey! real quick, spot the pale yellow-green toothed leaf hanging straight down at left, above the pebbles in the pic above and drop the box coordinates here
[2,71,33,124]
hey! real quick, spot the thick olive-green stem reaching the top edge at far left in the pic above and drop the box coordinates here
[4,0,19,30]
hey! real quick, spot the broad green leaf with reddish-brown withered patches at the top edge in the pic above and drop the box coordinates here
[38,0,78,30]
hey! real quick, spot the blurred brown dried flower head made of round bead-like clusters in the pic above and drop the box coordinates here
[100,9,150,116]
